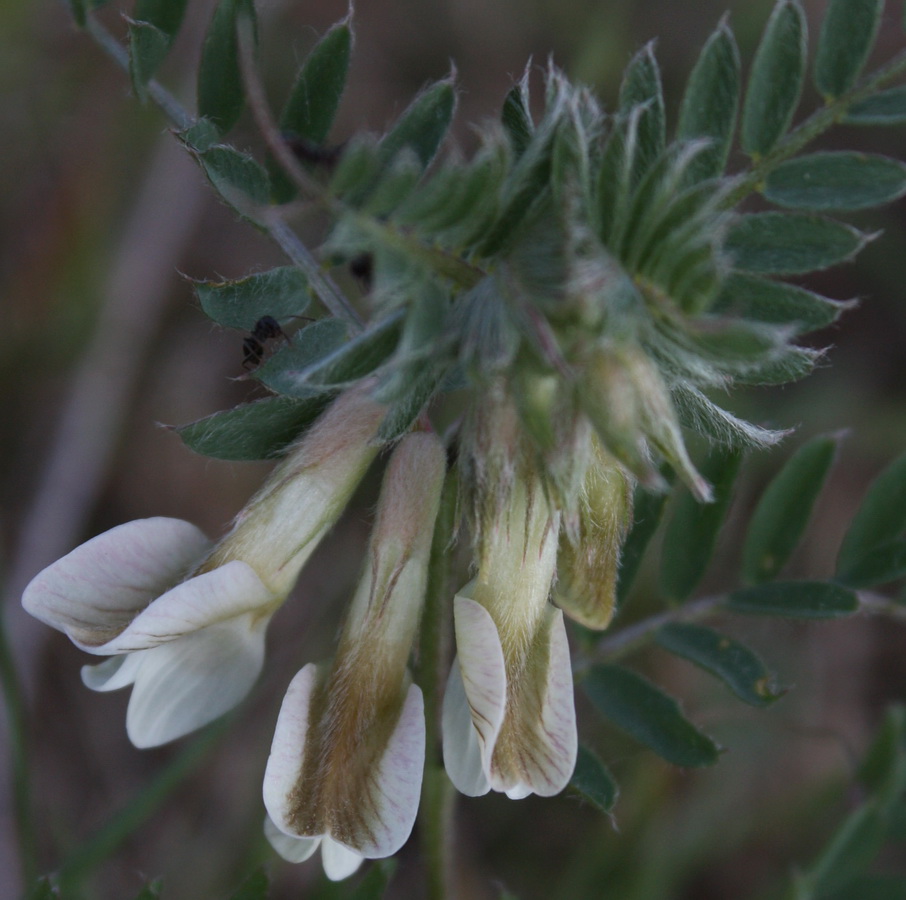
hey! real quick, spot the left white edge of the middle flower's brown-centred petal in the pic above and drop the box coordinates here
[264,663,318,836]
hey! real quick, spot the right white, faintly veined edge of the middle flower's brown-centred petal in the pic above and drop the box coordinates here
[354,684,425,856]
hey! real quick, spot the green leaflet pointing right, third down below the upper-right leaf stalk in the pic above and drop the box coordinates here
[712,272,856,334]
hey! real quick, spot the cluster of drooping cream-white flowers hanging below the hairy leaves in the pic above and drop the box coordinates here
[23,384,626,879]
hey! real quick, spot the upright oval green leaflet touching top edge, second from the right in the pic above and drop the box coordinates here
[740,0,808,157]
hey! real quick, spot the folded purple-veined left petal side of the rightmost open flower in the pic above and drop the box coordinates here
[444,594,507,793]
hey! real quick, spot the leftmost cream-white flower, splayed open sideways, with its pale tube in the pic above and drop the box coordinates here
[22,385,385,748]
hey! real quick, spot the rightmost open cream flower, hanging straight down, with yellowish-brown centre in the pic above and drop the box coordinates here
[443,474,577,799]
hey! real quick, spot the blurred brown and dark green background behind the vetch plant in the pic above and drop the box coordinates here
[0,0,906,900]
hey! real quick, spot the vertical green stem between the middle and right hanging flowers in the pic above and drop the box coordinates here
[418,474,457,900]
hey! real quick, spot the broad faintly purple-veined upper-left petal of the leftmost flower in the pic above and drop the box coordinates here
[22,517,211,645]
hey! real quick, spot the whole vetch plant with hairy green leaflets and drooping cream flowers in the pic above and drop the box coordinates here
[12,0,906,898]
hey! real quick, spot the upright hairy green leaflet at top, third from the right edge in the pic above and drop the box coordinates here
[676,19,740,181]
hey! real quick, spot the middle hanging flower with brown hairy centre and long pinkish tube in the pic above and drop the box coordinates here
[264,432,446,880]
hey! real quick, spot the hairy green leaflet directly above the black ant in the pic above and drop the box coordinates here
[192,266,310,331]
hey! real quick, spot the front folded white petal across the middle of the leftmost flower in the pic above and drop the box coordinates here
[94,560,275,654]
